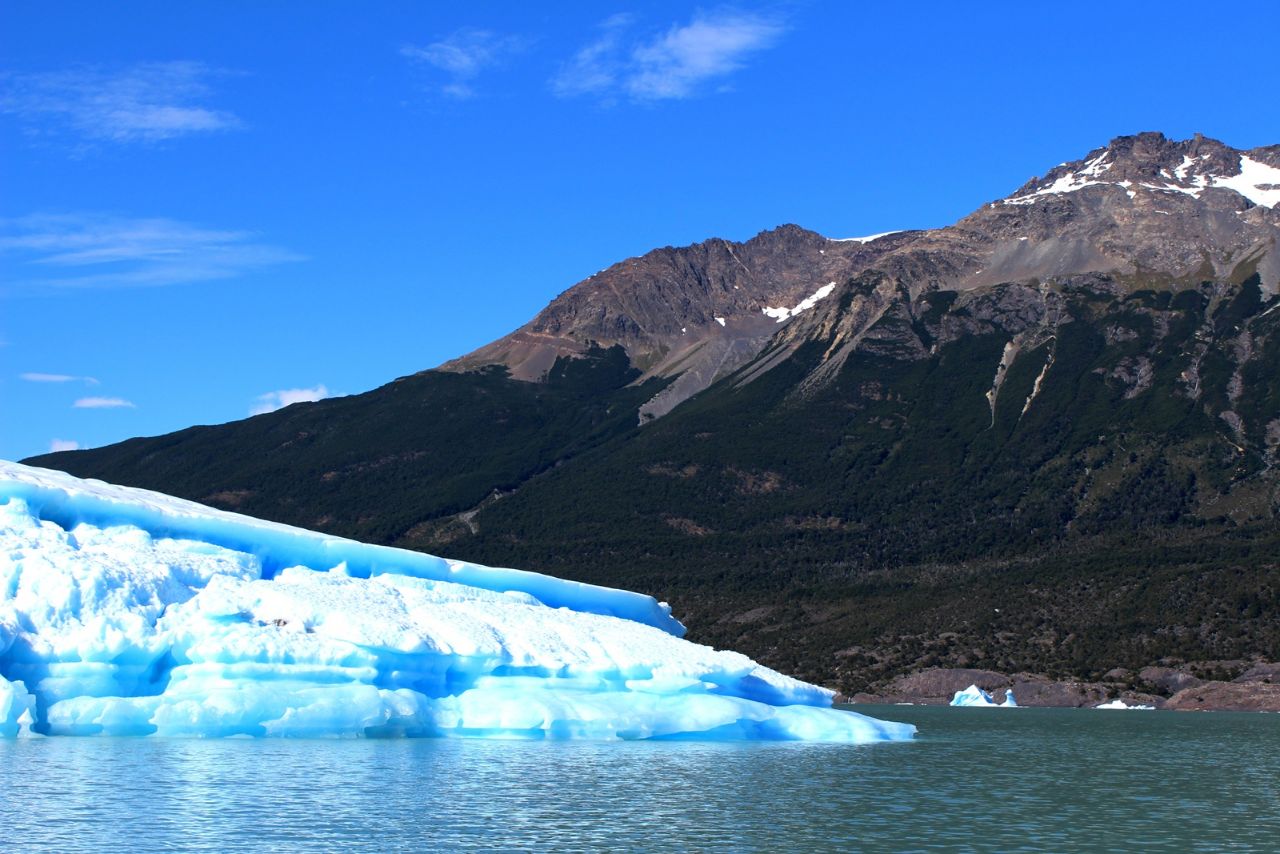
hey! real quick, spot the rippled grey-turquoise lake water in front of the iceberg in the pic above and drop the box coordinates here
[0,707,1280,851]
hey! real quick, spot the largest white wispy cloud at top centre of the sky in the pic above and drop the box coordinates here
[552,10,786,102]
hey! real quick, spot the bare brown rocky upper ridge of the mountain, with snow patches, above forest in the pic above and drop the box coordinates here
[442,133,1280,419]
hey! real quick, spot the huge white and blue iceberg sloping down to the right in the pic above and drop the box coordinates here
[0,461,915,743]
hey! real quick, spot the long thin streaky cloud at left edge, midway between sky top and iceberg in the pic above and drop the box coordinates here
[0,214,303,291]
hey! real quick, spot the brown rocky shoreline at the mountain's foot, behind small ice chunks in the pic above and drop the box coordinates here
[836,661,1280,712]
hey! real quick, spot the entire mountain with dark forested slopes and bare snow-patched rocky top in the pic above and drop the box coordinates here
[32,133,1280,693]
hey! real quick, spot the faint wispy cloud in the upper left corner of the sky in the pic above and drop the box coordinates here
[0,61,243,143]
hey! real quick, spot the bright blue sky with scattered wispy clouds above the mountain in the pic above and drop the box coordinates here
[0,0,1280,458]
